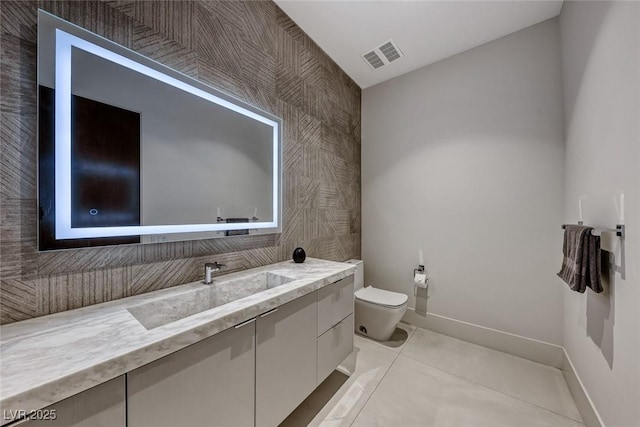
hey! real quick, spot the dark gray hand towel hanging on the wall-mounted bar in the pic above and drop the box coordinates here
[558,225,602,293]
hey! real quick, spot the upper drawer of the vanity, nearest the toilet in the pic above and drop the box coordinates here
[318,276,353,336]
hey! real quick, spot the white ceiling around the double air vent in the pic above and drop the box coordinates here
[275,0,562,89]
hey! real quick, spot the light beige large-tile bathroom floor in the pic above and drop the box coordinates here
[282,323,584,427]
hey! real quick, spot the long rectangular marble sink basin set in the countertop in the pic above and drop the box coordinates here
[128,271,295,329]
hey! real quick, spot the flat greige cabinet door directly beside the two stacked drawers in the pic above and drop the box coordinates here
[256,292,318,427]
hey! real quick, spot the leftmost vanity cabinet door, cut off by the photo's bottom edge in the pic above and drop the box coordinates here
[13,375,126,427]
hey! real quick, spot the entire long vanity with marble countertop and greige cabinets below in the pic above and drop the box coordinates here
[0,260,354,427]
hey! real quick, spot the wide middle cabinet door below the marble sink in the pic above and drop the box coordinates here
[127,321,255,427]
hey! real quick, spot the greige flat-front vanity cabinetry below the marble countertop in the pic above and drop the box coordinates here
[7,276,353,427]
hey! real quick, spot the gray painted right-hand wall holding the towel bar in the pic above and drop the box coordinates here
[560,1,640,427]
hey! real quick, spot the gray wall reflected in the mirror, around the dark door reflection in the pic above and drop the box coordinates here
[72,49,273,231]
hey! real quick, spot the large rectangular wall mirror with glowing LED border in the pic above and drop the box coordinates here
[38,11,281,250]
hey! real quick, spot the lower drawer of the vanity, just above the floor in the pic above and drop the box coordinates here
[317,313,353,384]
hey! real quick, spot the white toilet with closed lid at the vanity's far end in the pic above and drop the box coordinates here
[347,259,409,341]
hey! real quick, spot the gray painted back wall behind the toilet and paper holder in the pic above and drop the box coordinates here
[362,19,564,344]
